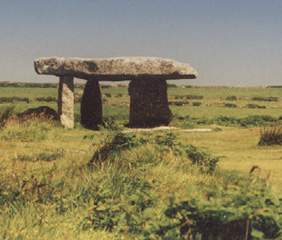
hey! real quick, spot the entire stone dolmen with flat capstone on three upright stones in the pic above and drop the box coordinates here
[34,57,197,129]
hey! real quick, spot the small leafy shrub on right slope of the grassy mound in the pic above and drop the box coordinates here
[186,145,220,173]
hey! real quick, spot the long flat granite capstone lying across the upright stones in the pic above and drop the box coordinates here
[34,57,197,81]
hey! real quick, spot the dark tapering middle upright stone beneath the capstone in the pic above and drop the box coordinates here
[80,79,103,130]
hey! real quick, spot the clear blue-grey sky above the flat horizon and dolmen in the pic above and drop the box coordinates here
[0,0,282,86]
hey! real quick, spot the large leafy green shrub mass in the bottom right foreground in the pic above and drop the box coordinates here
[155,174,282,240]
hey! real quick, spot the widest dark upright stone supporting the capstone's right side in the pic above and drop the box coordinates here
[128,79,172,127]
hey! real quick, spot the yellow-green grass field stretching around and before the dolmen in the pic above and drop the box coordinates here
[0,83,282,239]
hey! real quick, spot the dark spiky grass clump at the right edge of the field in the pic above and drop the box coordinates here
[258,125,282,146]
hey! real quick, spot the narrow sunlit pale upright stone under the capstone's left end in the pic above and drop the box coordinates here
[58,76,74,128]
